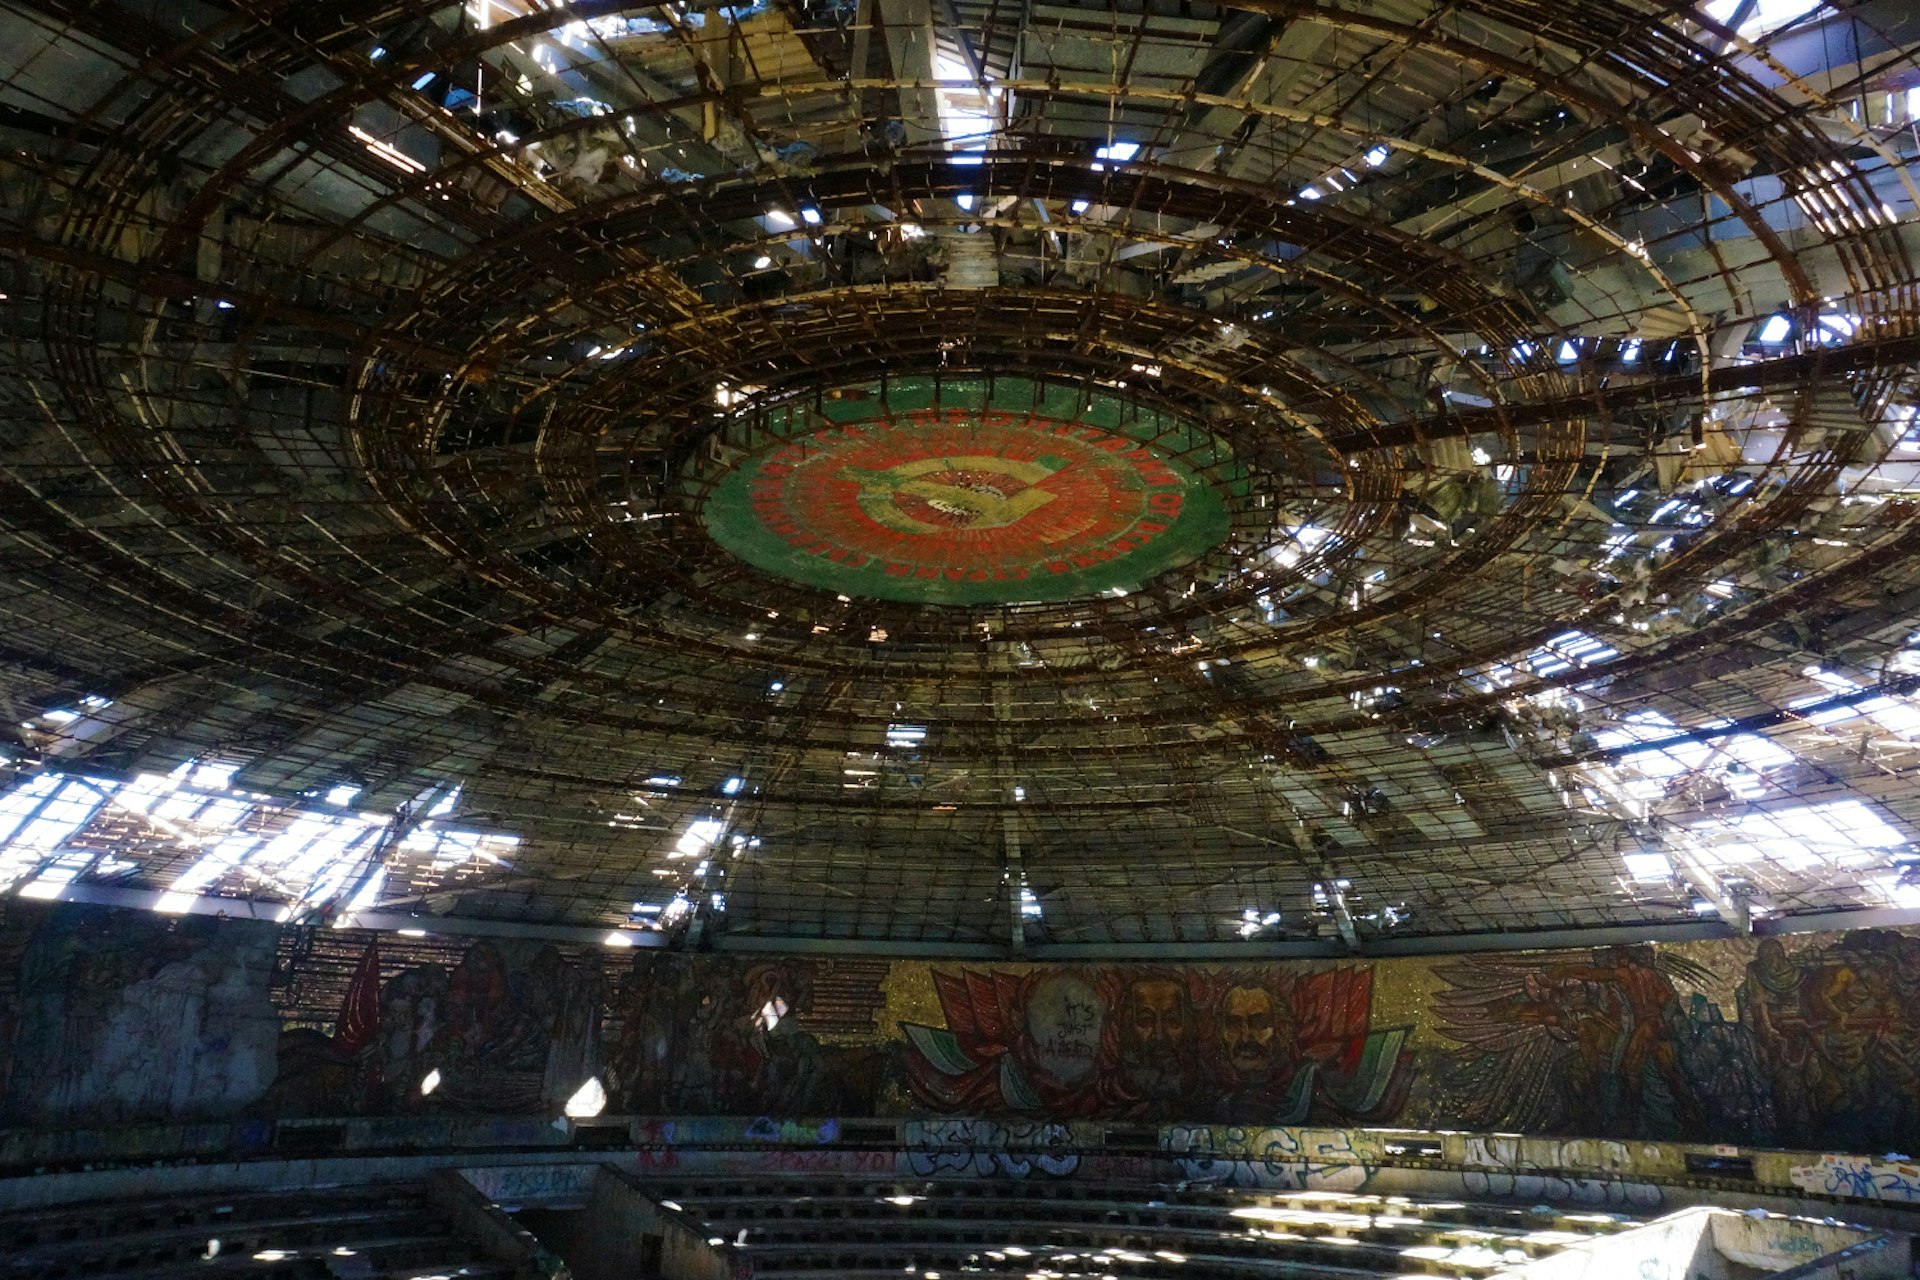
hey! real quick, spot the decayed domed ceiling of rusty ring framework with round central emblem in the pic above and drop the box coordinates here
[0,0,1920,956]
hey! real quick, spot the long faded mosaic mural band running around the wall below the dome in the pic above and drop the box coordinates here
[0,904,1920,1159]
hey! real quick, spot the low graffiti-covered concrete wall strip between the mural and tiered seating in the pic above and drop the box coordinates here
[11,1117,1920,1228]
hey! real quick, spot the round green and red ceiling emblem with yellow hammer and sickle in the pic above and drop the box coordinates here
[689,378,1244,604]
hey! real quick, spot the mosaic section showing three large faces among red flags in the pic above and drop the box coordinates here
[902,965,1411,1125]
